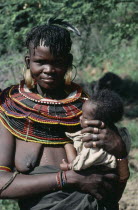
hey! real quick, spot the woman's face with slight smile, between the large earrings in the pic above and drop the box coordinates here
[25,45,67,90]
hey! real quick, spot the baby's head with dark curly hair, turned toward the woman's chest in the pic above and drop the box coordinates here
[80,89,124,128]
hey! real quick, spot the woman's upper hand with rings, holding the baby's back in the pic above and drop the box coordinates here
[81,120,127,159]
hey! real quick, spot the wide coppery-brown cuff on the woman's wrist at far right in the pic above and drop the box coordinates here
[117,158,130,182]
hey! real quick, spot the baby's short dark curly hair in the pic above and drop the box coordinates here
[90,89,124,126]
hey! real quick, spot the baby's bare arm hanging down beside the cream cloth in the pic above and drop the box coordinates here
[60,143,77,171]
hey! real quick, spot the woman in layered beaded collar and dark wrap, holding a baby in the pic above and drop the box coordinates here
[0,19,127,210]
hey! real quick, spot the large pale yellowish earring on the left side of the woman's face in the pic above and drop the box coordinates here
[24,69,34,89]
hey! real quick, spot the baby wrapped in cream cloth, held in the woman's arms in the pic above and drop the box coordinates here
[60,89,124,171]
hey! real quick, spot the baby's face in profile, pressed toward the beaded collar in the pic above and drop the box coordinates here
[80,101,97,128]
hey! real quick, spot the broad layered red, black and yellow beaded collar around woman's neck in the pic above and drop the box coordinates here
[0,81,88,144]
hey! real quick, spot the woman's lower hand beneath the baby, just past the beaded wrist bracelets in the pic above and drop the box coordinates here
[66,169,118,200]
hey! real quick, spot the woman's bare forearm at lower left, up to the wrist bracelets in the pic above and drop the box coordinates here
[0,172,59,199]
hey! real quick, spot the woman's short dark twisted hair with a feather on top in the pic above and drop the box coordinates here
[26,18,80,56]
